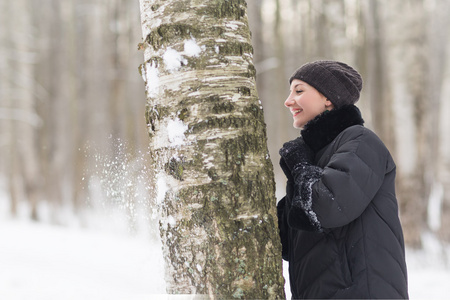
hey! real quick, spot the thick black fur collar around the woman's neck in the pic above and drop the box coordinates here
[301,105,364,152]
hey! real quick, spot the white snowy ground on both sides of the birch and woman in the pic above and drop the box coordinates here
[0,217,450,300]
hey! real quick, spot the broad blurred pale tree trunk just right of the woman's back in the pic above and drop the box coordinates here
[380,1,431,247]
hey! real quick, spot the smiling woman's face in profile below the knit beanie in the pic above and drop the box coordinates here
[284,79,333,128]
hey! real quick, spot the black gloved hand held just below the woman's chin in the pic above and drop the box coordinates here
[279,137,314,173]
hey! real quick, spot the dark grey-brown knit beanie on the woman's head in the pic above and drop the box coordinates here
[289,60,362,108]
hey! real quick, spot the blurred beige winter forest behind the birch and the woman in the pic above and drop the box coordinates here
[0,0,450,247]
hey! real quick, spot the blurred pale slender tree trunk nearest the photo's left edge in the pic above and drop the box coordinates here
[10,0,42,220]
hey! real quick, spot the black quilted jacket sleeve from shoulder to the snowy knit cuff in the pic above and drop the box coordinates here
[311,128,395,228]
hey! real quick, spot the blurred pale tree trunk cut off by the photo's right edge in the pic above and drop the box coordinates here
[426,1,450,242]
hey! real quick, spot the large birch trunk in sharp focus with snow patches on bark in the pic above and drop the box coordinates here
[140,0,284,299]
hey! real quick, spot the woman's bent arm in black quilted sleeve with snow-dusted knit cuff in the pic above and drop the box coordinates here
[286,127,395,232]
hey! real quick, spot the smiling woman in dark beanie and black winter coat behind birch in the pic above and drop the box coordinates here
[277,61,408,299]
